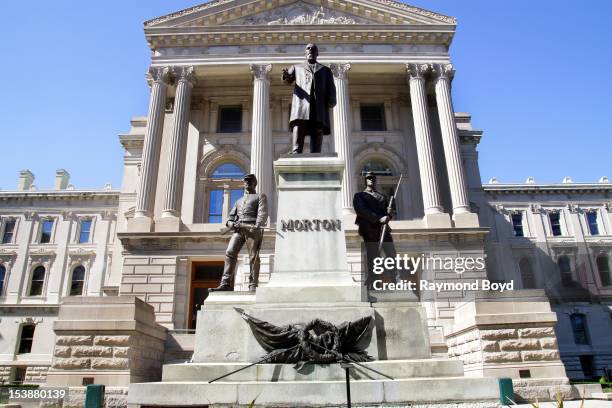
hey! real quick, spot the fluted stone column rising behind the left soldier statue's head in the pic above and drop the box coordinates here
[250,64,273,218]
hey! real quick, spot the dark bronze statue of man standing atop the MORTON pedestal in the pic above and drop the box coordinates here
[282,44,336,154]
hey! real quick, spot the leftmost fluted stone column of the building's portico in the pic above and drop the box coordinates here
[134,67,170,218]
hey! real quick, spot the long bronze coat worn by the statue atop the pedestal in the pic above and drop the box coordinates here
[284,62,336,135]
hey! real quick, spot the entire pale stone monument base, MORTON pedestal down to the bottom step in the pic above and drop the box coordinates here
[128,154,498,407]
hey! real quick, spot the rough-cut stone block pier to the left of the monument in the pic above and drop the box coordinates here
[47,296,167,387]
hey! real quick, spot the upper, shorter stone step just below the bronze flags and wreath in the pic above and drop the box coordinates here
[162,359,463,382]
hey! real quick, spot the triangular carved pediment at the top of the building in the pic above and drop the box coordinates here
[145,0,456,29]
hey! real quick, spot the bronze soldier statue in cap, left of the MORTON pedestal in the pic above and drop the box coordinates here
[210,174,268,292]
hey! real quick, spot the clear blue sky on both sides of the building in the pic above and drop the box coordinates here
[0,0,612,190]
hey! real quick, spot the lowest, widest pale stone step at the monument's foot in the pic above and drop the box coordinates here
[128,378,499,407]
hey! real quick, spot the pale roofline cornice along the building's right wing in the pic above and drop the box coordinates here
[482,183,612,194]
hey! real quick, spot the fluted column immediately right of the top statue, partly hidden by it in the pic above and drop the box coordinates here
[329,64,355,213]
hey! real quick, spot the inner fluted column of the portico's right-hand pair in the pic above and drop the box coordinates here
[406,64,450,228]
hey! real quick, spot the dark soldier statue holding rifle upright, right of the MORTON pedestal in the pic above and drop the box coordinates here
[353,171,401,289]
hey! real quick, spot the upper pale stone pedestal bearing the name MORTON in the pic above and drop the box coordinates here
[257,154,364,303]
